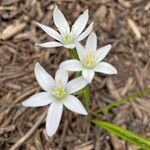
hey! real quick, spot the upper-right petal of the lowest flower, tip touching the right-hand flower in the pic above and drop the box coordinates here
[66,77,87,94]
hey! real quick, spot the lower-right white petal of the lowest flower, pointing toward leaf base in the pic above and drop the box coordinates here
[63,95,88,115]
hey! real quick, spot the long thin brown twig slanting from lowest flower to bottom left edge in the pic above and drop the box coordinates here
[10,110,47,150]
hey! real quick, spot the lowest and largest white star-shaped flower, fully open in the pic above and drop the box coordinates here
[22,63,87,136]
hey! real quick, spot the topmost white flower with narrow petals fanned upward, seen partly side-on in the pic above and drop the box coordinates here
[36,6,93,49]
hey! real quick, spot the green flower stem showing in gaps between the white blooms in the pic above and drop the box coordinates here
[69,48,90,111]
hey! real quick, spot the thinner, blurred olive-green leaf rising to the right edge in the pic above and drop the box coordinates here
[95,89,150,113]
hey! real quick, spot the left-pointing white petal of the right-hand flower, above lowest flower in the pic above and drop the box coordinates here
[60,59,82,71]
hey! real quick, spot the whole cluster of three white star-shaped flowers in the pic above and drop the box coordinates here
[22,6,117,136]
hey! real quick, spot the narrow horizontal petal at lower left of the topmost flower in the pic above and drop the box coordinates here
[36,41,63,48]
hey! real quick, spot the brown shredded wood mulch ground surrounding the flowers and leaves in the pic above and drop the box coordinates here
[0,0,150,150]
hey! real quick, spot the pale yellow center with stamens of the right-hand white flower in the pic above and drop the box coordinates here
[83,51,95,68]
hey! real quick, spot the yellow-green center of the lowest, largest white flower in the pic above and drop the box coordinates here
[53,86,66,98]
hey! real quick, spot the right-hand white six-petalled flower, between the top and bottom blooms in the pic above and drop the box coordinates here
[60,32,117,83]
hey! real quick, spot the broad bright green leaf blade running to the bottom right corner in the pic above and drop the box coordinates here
[92,119,150,150]
